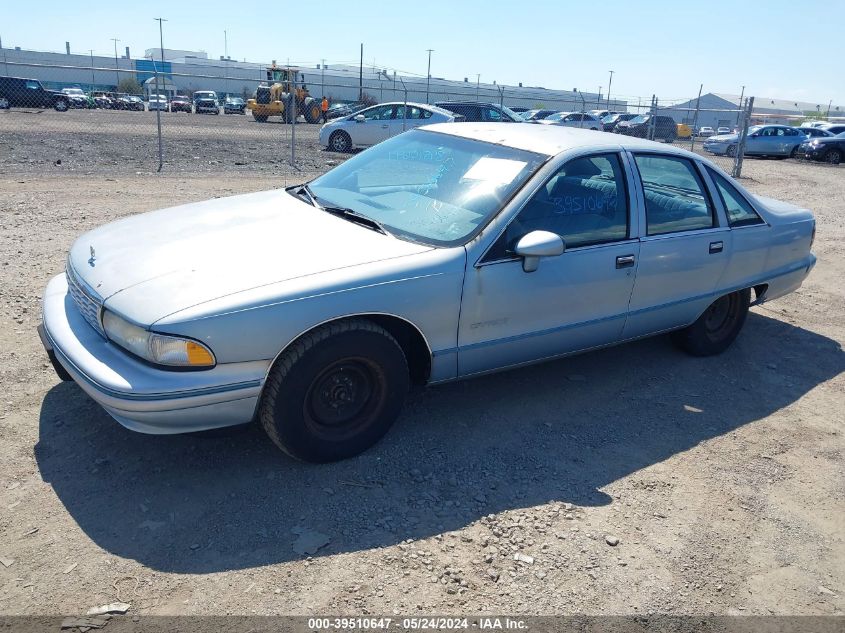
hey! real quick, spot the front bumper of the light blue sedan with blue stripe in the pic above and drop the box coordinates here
[39,274,271,435]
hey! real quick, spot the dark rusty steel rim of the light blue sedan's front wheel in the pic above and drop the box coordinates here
[304,358,386,441]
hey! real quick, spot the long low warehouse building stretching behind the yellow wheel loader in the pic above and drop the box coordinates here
[0,44,627,111]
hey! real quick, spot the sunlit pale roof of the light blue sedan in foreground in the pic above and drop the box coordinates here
[421,122,701,159]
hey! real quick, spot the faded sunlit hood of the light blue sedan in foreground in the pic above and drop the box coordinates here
[68,190,431,325]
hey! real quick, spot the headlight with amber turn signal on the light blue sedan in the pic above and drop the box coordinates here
[103,310,217,368]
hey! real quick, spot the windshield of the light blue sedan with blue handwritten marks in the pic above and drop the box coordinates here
[310,130,548,246]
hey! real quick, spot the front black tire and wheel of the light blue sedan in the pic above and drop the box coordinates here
[258,319,410,463]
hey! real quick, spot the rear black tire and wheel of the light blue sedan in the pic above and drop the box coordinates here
[672,288,751,356]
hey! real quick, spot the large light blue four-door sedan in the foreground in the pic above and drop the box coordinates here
[39,123,816,462]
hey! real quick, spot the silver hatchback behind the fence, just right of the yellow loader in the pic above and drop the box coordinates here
[319,102,459,152]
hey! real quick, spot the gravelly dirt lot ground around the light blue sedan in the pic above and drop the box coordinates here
[0,112,845,615]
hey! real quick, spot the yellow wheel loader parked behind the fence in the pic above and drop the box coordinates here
[247,61,322,123]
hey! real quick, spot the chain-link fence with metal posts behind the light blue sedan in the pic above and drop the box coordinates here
[0,58,753,176]
